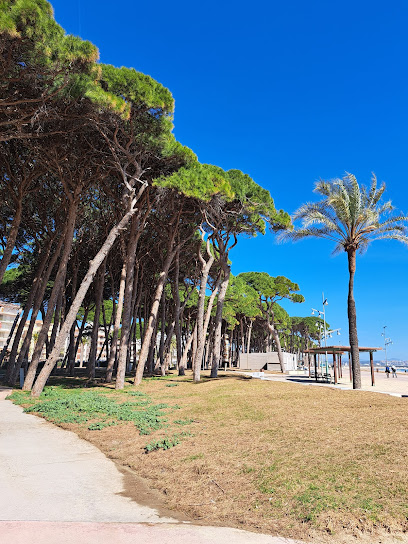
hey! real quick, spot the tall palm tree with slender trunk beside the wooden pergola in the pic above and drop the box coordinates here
[282,173,408,389]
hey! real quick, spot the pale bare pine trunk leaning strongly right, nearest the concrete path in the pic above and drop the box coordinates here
[31,200,143,397]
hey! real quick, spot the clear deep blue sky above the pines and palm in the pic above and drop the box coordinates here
[52,0,408,359]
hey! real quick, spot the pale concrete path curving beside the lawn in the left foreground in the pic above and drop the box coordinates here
[0,389,300,544]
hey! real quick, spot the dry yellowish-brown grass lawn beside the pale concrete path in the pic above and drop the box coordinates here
[8,374,408,542]
